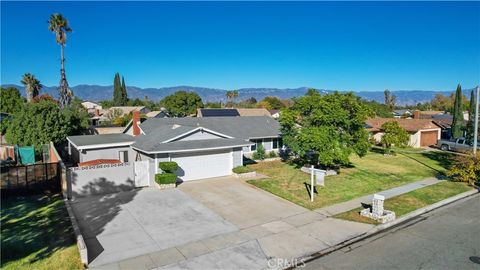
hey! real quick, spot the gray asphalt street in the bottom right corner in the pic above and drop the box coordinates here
[304,194,480,270]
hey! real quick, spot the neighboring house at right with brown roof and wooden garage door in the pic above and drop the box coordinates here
[366,118,441,147]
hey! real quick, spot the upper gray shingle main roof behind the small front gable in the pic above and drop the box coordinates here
[140,116,280,141]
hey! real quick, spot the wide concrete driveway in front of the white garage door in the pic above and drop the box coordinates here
[72,177,372,270]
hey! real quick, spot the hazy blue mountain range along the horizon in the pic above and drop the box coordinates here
[2,84,471,105]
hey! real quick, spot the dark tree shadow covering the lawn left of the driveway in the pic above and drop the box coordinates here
[1,194,75,265]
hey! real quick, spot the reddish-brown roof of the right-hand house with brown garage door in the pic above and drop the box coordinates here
[366,118,439,133]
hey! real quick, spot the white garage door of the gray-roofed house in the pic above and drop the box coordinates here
[171,149,233,181]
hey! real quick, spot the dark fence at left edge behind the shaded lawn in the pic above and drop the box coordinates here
[0,162,61,197]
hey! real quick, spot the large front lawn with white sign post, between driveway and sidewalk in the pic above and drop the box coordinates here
[248,152,449,209]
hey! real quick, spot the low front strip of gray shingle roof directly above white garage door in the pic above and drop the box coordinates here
[132,138,253,153]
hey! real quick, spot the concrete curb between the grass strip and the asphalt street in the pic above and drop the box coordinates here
[285,189,480,269]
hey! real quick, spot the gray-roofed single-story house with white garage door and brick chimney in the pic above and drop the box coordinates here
[68,112,282,184]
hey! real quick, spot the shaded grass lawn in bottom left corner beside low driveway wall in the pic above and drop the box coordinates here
[1,195,83,270]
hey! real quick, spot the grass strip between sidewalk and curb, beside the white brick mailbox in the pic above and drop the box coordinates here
[334,181,472,224]
